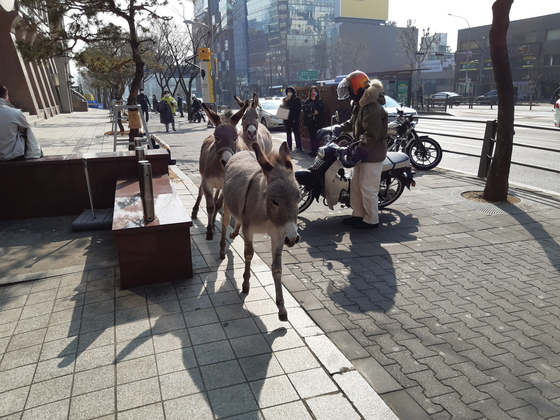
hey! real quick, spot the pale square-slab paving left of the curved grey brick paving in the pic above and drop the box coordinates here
[0,112,397,420]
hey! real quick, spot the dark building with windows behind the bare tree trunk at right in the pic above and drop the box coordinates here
[455,13,560,101]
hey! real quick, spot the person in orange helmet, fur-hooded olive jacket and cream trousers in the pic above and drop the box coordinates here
[337,71,387,229]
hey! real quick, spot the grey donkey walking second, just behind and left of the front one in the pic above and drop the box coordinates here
[191,103,248,241]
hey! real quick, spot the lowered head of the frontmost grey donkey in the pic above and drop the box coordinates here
[252,142,300,247]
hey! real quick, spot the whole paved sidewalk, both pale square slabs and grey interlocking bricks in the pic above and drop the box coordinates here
[0,109,560,419]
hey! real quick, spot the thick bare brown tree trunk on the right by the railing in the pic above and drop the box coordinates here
[483,0,514,202]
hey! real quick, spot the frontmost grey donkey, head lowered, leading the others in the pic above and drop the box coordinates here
[220,142,300,321]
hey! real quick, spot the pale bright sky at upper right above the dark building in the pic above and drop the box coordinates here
[389,0,560,52]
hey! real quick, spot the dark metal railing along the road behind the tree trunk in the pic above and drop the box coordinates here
[416,116,560,178]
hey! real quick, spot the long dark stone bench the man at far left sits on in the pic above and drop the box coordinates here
[0,149,169,220]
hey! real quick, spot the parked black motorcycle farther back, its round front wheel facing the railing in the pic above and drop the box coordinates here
[387,109,443,170]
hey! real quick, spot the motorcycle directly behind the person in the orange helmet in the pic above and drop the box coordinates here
[295,116,416,213]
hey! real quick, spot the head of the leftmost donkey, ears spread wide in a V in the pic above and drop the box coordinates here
[202,103,249,167]
